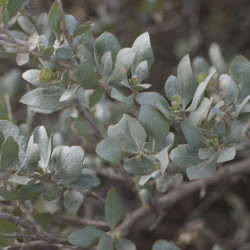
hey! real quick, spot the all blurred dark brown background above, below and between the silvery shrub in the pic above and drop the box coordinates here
[0,0,250,250]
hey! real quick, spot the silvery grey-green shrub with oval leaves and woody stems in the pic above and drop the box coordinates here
[0,0,250,250]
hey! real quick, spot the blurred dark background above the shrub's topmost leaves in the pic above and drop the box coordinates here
[28,0,250,93]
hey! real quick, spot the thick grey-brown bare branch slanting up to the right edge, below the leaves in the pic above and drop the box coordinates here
[115,159,250,234]
